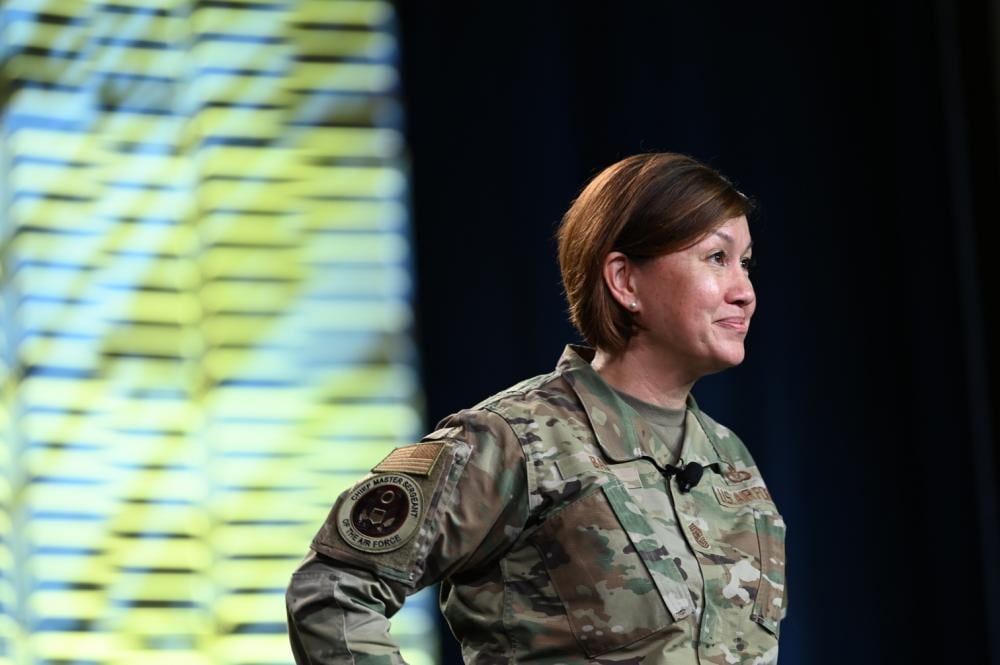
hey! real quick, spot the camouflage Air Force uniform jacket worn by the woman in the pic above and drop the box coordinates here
[287,347,785,665]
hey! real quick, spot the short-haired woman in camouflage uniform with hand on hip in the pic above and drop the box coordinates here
[287,153,785,665]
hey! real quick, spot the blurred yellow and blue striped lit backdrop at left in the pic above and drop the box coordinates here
[0,0,436,665]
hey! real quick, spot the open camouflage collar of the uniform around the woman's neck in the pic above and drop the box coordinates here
[556,344,720,469]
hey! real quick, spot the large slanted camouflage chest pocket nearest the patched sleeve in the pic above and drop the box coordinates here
[530,482,693,657]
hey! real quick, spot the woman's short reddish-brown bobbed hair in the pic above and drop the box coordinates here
[558,152,753,353]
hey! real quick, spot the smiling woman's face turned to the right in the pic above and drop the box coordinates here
[632,216,756,380]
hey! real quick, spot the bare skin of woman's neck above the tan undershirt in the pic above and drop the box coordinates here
[590,344,694,409]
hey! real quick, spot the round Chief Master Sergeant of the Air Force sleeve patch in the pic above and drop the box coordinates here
[337,473,424,553]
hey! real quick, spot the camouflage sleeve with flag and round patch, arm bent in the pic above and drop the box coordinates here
[286,411,528,665]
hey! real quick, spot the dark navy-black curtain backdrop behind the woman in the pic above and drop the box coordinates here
[398,0,1000,665]
